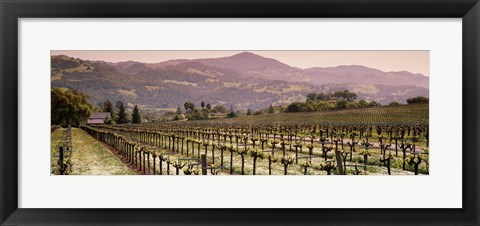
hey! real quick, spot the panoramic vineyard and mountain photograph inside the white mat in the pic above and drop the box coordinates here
[50,50,430,176]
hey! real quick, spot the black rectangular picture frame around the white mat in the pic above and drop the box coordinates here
[0,0,480,226]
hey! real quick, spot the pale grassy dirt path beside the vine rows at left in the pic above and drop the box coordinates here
[71,128,137,175]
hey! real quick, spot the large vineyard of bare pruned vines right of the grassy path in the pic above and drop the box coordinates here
[51,105,429,175]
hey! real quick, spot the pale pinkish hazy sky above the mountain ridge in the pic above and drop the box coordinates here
[51,50,430,76]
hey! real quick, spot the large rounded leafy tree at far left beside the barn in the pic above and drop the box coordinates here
[51,88,93,125]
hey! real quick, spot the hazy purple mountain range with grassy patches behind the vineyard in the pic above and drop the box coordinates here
[51,52,429,110]
